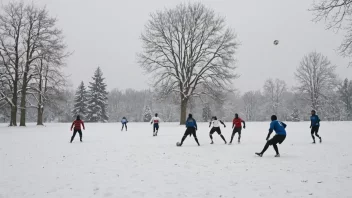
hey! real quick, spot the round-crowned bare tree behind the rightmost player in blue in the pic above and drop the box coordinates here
[295,52,336,111]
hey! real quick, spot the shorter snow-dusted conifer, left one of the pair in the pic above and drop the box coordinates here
[72,81,88,119]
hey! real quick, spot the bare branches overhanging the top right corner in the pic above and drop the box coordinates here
[311,0,352,66]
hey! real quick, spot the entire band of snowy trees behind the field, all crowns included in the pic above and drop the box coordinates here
[0,0,352,126]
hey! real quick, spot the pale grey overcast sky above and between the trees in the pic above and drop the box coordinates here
[0,0,352,92]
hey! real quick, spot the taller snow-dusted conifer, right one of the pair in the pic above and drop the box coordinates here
[87,67,109,122]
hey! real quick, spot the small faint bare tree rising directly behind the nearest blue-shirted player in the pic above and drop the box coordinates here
[264,79,287,115]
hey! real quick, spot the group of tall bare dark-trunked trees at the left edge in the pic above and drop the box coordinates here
[0,2,69,126]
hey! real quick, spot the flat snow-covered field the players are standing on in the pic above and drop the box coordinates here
[0,122,352,198]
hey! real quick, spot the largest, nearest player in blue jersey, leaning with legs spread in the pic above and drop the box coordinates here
[255,115,287,157]
